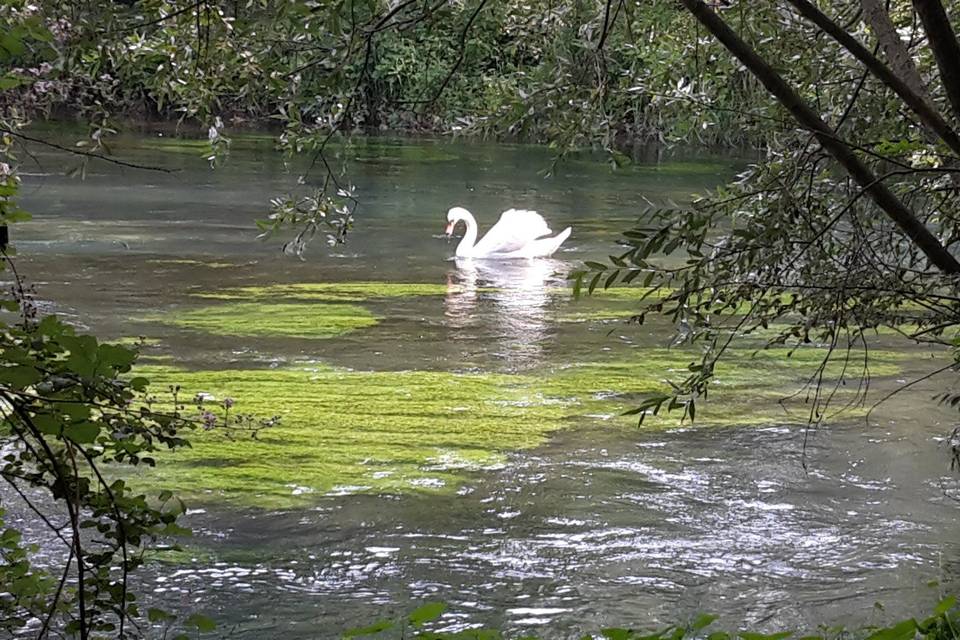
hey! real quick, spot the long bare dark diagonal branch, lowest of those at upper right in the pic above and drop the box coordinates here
[680,0,960,274]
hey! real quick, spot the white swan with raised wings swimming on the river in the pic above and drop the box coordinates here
[447,207,570,258]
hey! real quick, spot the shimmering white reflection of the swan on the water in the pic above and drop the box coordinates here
[444,259,566,368]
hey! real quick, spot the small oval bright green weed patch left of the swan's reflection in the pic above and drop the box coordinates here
[150,302,377,339]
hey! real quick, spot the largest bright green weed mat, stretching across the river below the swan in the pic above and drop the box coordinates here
[129,349,898,507]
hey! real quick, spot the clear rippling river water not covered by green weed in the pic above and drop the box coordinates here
[7,132,960,638]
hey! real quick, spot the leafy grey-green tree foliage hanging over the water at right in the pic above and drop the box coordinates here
[578,0,960,422]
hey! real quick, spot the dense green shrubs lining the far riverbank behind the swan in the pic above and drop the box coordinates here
[4,1,762,147]
